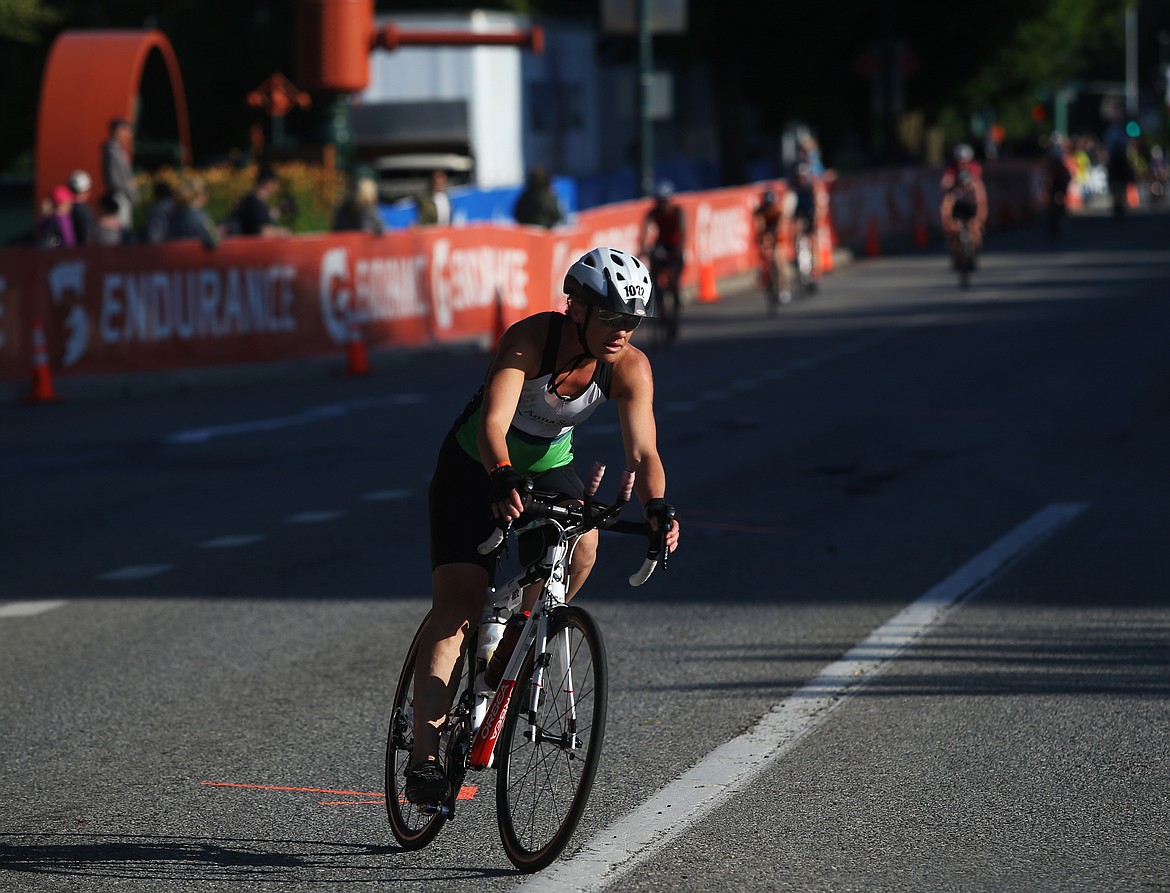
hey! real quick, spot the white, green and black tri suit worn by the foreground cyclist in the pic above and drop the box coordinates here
[429,314,613,572]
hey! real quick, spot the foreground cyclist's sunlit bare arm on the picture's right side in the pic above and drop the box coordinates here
[613,346,679,551]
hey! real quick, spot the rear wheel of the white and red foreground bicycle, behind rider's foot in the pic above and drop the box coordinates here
[386,613,463,850]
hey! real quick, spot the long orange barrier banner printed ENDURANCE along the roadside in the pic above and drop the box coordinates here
[0,166,1031,380]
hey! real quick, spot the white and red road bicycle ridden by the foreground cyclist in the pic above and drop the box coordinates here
[386,465,673,872]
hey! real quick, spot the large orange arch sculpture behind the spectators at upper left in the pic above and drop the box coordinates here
[34,30,191,213]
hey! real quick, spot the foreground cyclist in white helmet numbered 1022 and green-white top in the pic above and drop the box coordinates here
[405,248,679,804]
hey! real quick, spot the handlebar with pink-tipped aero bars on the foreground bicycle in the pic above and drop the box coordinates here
[477,463,675,586]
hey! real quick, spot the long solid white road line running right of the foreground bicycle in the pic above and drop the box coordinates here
[515,503,1088,893]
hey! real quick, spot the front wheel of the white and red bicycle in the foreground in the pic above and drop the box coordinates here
[496,605,608,872]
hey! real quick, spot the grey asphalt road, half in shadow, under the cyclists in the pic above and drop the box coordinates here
[0,205,1170,893]
